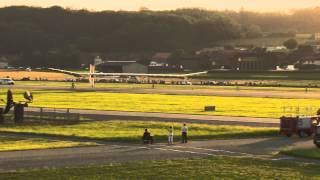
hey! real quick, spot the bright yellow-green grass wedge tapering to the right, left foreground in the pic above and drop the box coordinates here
[0,136,96,151]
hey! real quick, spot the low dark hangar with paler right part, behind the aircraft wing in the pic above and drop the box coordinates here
[96,61,148,73]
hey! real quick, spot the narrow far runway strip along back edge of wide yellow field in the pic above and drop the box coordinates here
[2,85,320,99]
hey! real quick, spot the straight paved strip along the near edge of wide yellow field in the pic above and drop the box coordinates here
[26,108,279,127]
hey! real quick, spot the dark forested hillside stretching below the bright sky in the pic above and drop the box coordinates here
[0,6,320,67]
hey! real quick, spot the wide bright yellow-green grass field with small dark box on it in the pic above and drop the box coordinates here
[2,90,320,118]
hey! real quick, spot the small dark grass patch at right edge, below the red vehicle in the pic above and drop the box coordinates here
[280,148,320,159]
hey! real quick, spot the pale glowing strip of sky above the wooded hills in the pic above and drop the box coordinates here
[0,0,320,11]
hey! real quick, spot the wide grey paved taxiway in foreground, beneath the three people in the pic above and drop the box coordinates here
[0,134,319,172]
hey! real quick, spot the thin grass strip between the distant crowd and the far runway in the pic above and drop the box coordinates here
[13,80,320,92]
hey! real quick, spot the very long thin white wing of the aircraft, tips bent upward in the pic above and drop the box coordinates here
[48,68,208,78]
